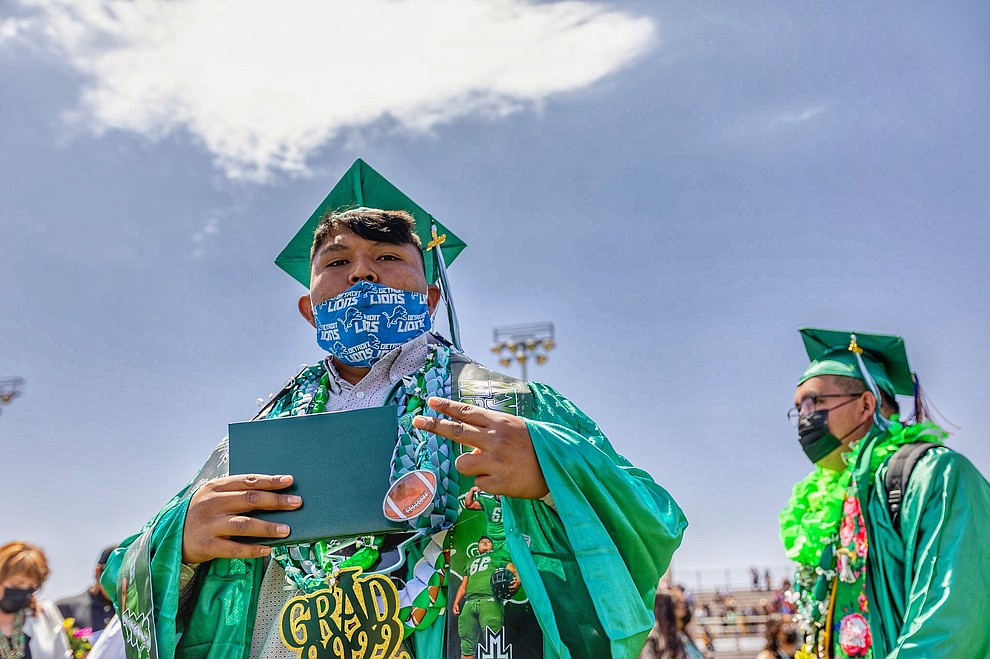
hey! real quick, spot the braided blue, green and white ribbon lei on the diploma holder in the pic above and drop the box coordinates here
[268,345,459,636]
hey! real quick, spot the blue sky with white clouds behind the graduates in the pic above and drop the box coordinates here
[0,0,990,596]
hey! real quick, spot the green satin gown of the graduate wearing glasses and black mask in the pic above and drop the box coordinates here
[869,448,990,659]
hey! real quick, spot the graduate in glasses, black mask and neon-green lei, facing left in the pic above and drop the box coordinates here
[781,329,990,659]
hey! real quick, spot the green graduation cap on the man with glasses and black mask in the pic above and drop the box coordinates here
[798,327,915,397]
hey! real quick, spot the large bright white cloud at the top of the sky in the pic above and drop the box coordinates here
[11,0,656,179]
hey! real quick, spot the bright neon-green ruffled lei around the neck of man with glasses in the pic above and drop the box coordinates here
[780,414,948,567]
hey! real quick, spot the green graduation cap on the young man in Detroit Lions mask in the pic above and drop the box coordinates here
[275,158,465,288]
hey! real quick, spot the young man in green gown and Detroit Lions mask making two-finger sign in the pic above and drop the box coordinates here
[104,160,687,659]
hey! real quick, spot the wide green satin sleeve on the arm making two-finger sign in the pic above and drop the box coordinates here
[503,383,687,657]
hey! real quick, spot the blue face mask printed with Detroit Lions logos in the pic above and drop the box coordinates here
[313,281,432,368]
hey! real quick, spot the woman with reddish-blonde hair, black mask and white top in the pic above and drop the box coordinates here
[0,541,72,659]
